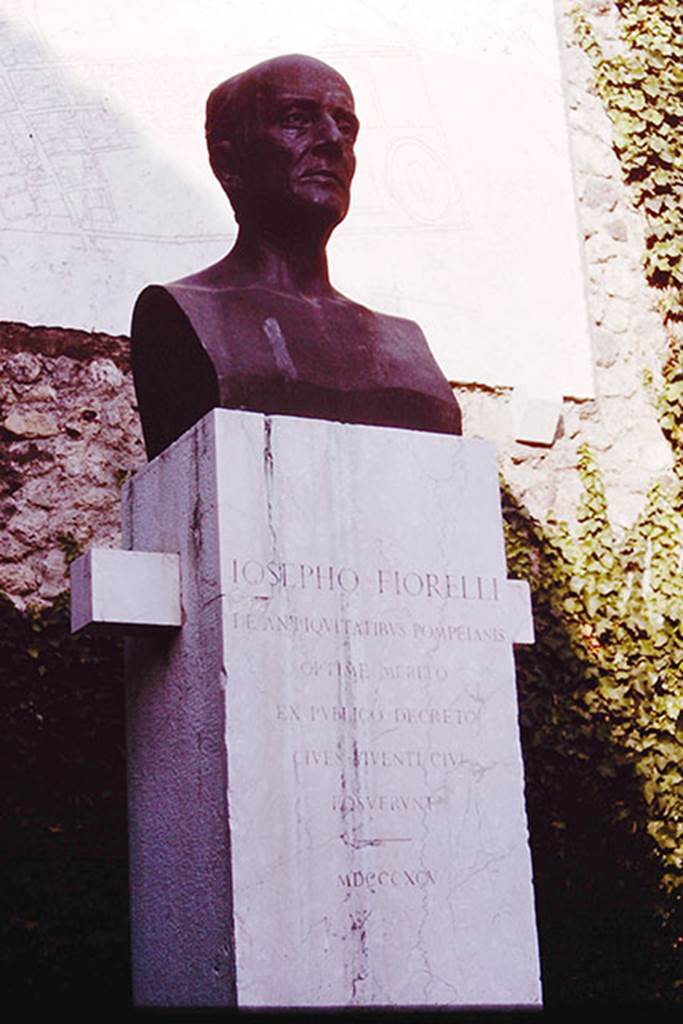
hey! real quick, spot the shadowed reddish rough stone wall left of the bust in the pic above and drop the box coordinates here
[0,324,144,607]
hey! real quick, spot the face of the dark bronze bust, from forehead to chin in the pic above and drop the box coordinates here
[241,58,358,229]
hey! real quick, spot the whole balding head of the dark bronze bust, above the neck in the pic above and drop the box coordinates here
[206,54,358,241]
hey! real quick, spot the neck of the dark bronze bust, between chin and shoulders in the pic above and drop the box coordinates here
[225,226,333,298]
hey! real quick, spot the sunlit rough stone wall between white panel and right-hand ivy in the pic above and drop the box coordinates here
[457,0,673,531]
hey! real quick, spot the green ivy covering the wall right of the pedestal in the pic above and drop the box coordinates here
[505,0,683,1004]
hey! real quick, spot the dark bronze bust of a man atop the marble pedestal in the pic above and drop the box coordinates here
[132,55,461,459]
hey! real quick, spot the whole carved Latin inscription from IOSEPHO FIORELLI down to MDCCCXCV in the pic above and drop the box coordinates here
[227,558,509,899]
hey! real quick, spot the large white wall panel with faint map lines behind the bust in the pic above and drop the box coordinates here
[0,0,593,396]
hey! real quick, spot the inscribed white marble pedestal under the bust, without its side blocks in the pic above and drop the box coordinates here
[124,411,541,1007]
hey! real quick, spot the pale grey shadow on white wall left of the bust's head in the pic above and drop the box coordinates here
[0,16,229,334]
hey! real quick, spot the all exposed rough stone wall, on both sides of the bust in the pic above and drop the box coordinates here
[0,0,672,606]
